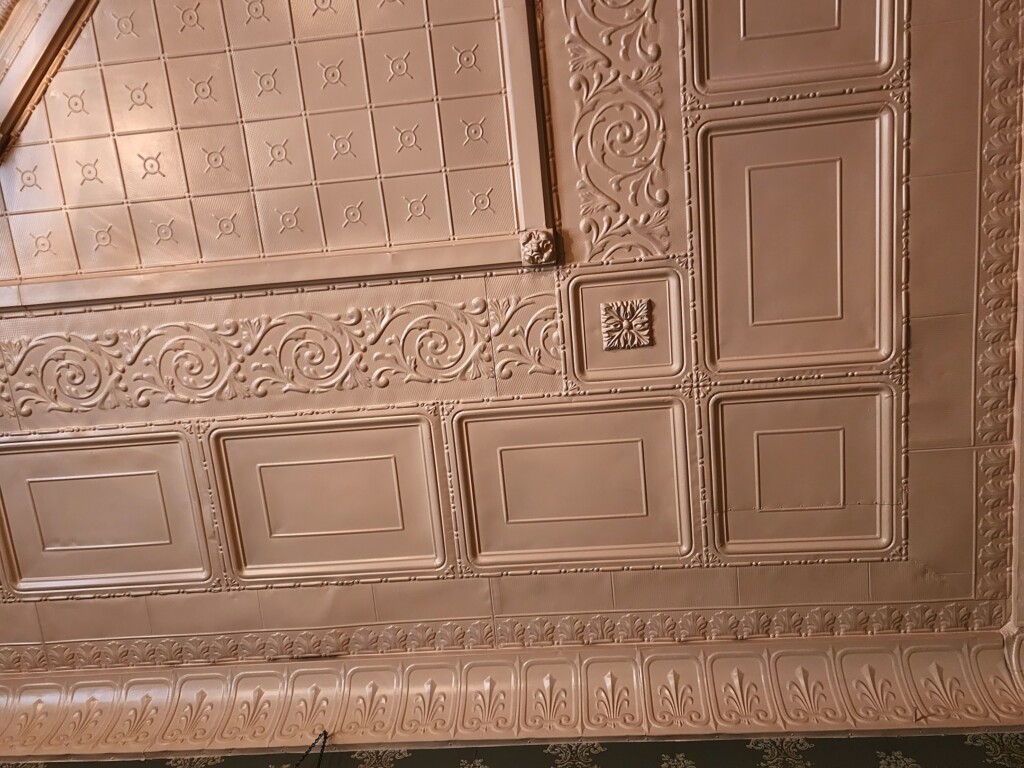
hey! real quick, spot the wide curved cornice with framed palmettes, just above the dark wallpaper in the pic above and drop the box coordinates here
[0,633,1024,756]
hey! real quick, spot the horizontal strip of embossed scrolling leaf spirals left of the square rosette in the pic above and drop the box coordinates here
[0,293,561,417]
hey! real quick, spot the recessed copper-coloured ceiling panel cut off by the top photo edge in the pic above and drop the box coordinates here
[693,0,896,93]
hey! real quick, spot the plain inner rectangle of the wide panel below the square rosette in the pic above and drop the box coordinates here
[498,440,647,523]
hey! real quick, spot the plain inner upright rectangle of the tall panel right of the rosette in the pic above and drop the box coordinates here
[746,159,843,326]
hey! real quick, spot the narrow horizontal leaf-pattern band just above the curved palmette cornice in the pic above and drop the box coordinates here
[0,601,1007,673]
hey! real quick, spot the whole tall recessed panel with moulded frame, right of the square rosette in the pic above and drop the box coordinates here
[698,103,895,371]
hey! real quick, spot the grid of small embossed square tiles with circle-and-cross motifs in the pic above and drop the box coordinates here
[0,0,518,276]
